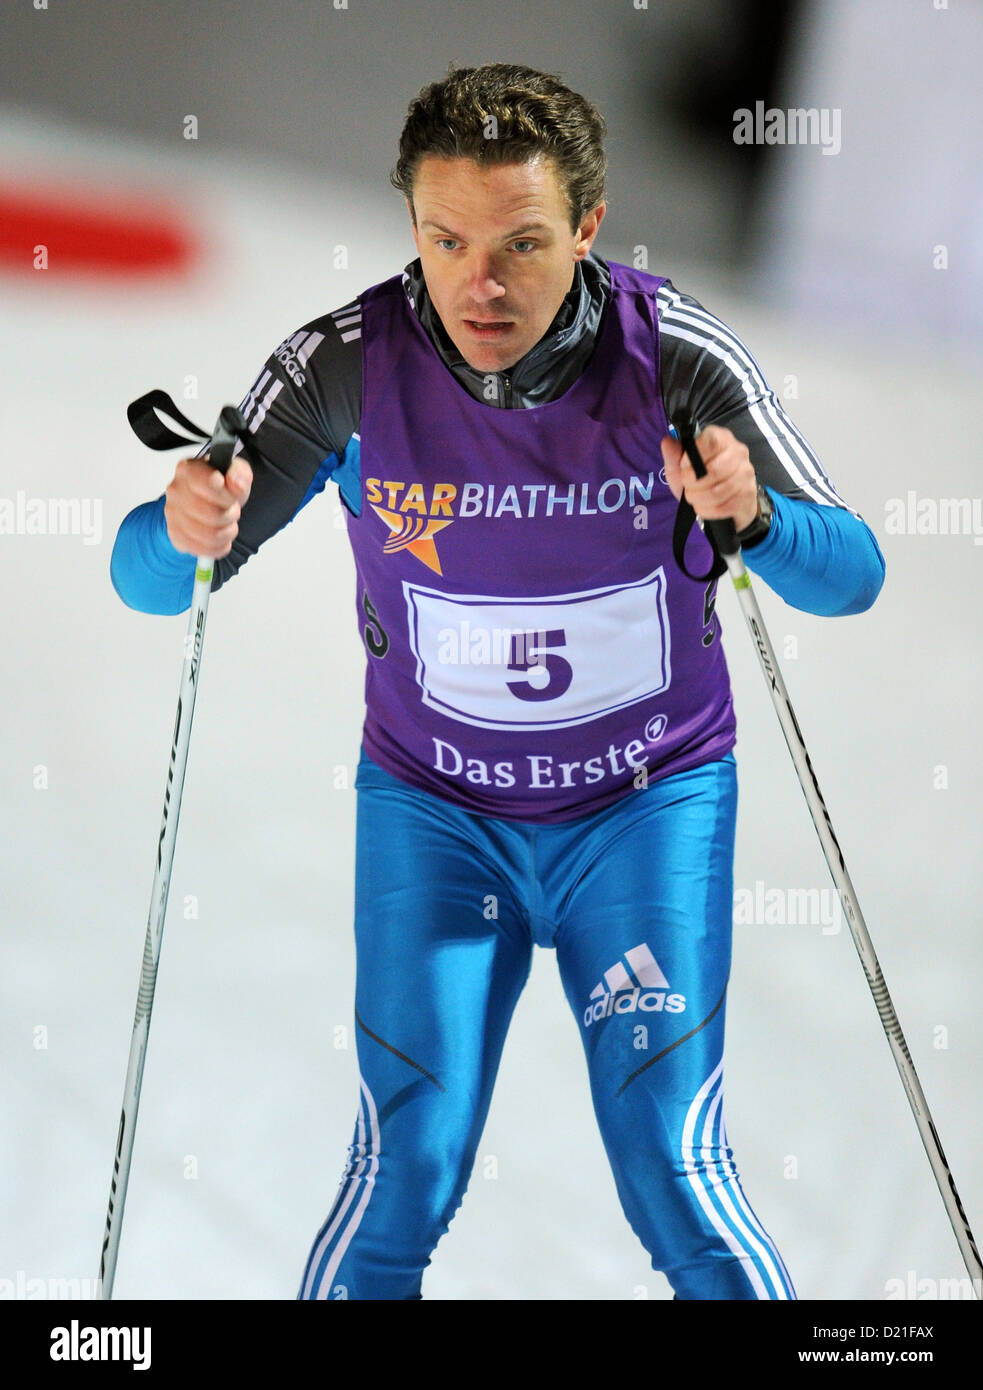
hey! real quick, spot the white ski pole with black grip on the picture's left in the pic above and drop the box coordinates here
[97,406,246,1298]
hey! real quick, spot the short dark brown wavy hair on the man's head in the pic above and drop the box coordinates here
[389,63,608,231]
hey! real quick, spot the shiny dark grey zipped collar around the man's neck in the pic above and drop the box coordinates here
[403,254,610,409]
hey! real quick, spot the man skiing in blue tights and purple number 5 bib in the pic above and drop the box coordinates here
[111,64,884,1300]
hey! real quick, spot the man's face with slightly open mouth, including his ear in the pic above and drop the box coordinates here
[407,154,605,371]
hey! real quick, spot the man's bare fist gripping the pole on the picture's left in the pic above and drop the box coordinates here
[164,456,253,560]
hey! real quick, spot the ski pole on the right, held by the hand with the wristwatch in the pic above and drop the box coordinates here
[674,407,983,1298]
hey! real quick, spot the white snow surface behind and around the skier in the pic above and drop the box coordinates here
[0,113,983,1300]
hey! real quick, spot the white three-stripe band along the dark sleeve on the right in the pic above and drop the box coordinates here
[658,285,859,516]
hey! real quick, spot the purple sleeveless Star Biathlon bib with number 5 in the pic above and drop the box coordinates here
[346,263,736,821]
